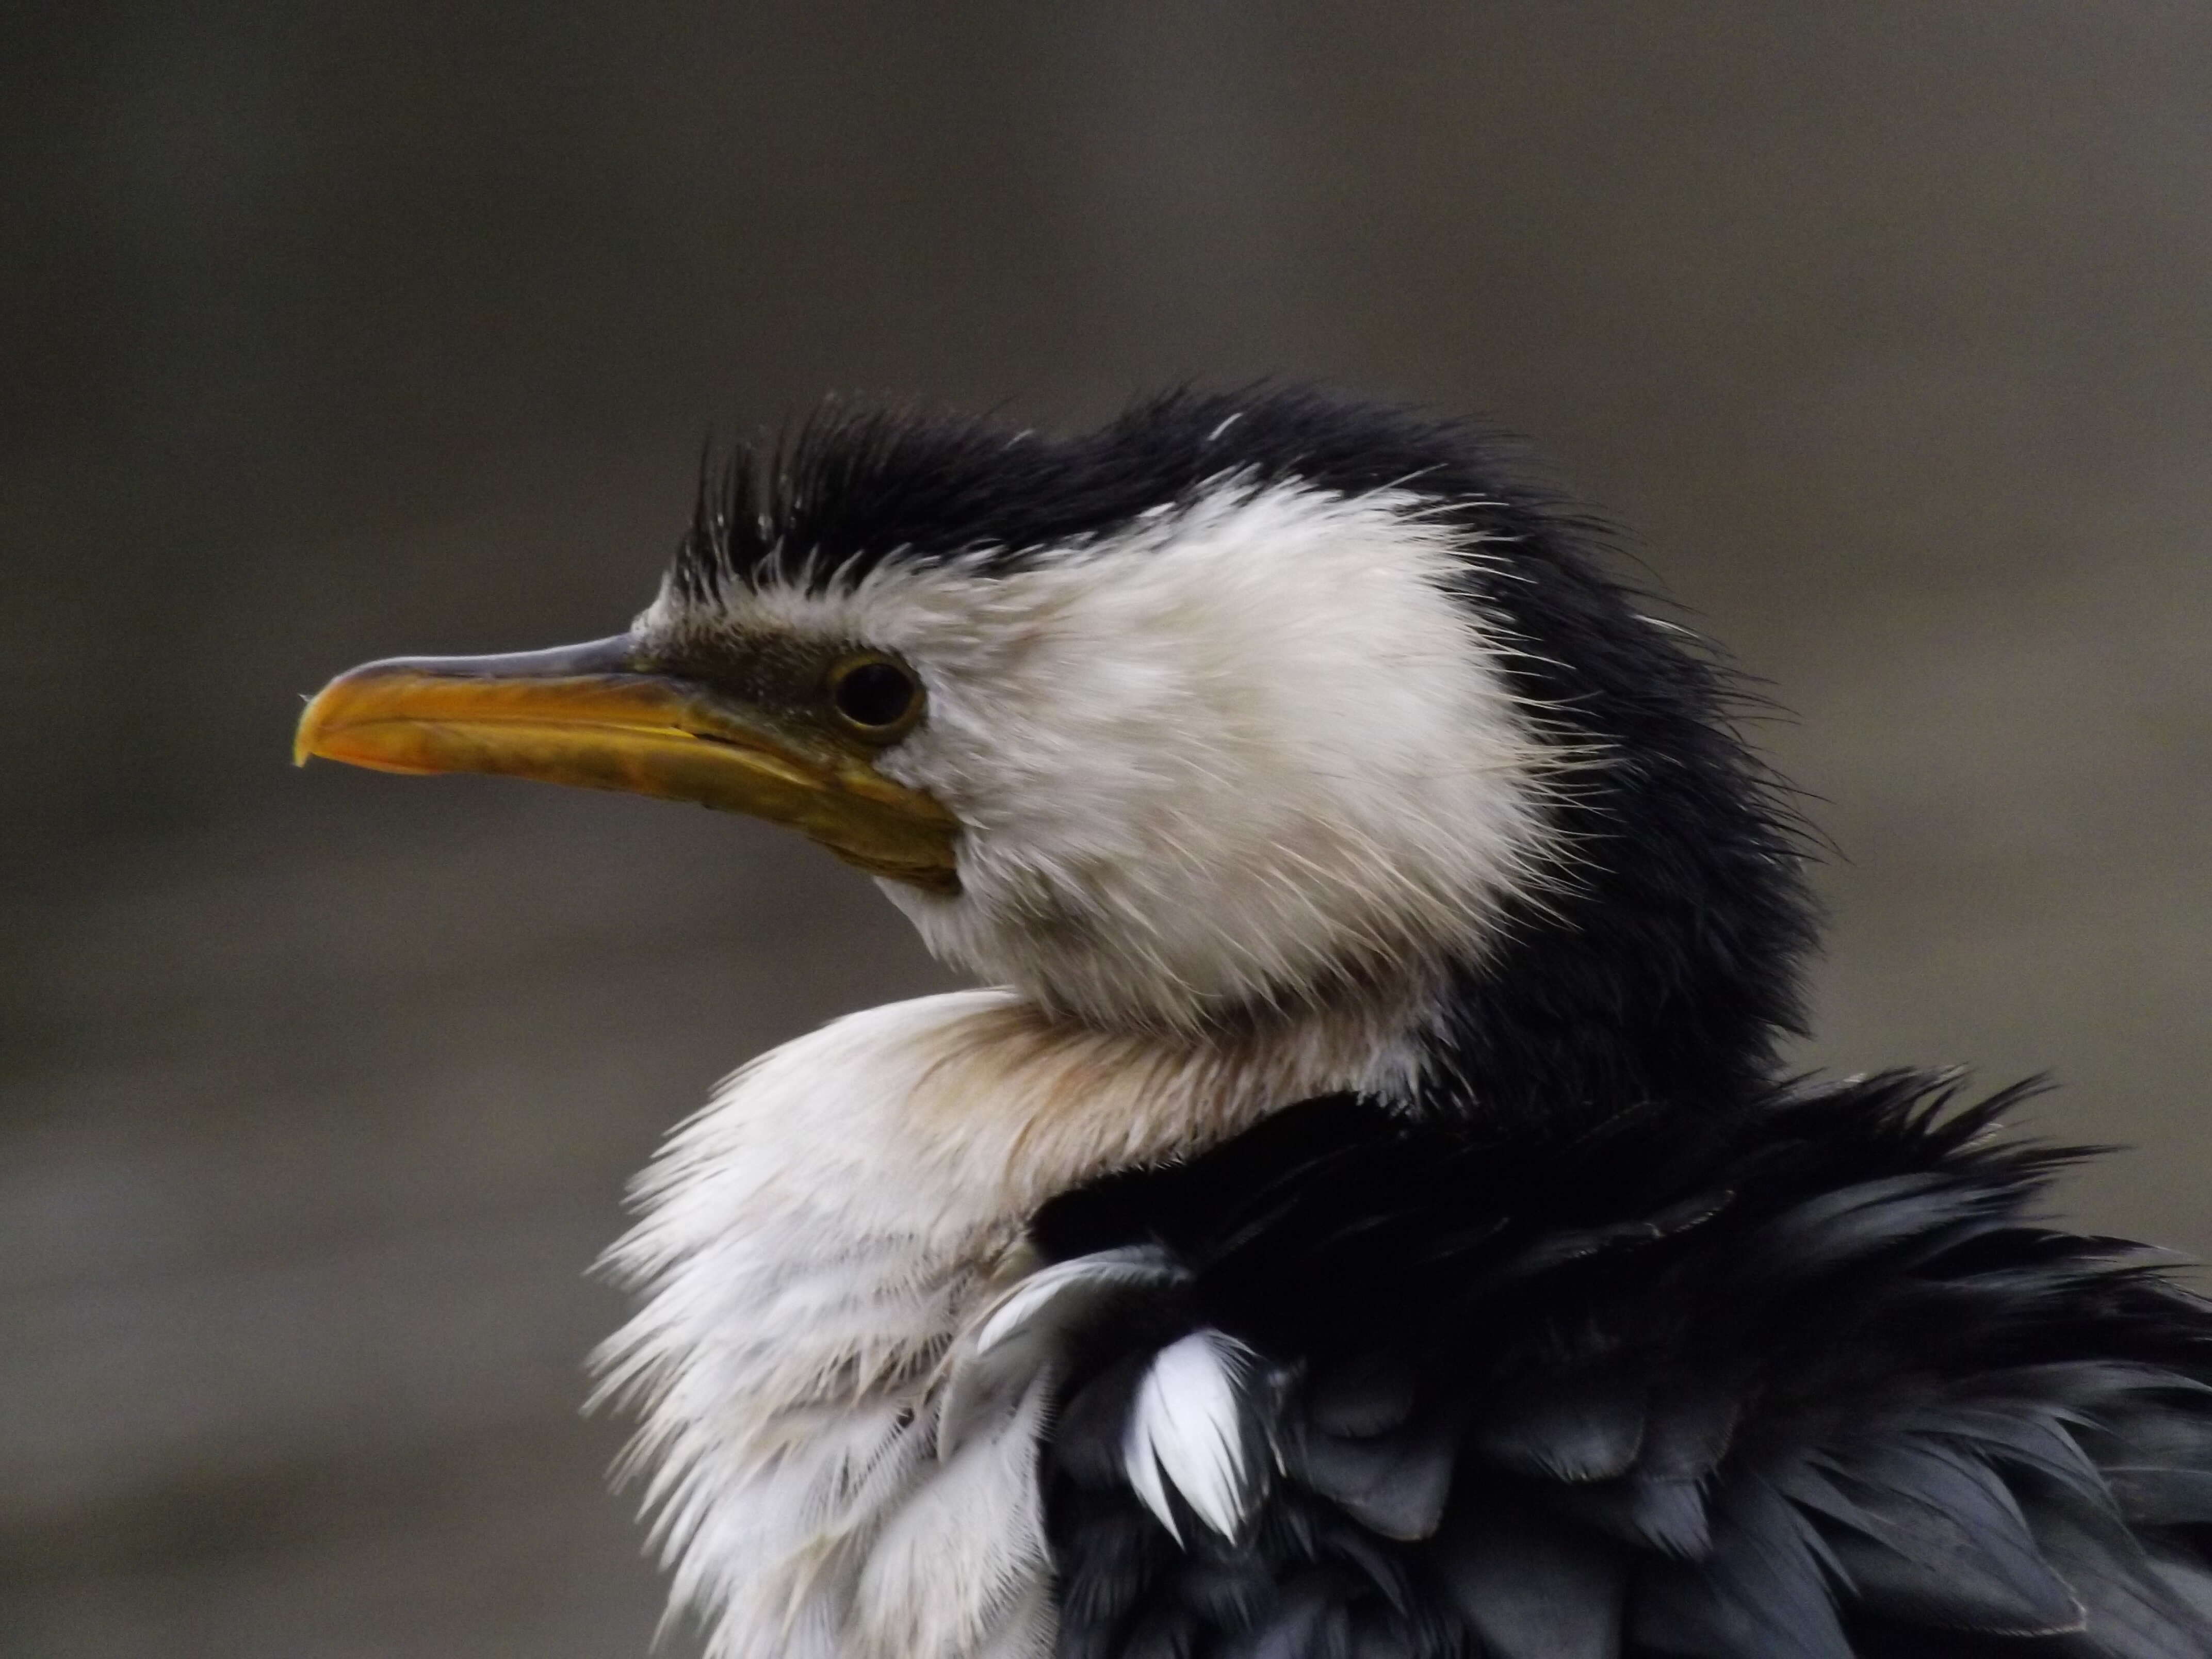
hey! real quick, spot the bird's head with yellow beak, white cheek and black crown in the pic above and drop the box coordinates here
[299,392,1805,1106]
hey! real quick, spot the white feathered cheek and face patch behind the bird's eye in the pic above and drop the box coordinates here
[639,476,1592,1031]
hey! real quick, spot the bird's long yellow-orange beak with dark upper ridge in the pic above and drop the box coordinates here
[292,637,960,893]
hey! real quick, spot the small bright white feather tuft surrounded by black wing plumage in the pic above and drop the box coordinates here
[1121,1329,1252,1544]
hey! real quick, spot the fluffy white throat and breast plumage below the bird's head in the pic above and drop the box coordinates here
[601,991,1407,1659]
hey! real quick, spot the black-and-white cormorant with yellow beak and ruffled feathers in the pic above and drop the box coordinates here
[297,385,2212,1659]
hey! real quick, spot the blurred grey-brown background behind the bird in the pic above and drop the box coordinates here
[0,0,2212,1659]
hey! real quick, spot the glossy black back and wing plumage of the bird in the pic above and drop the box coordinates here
[1035,1073,2212,1659]
